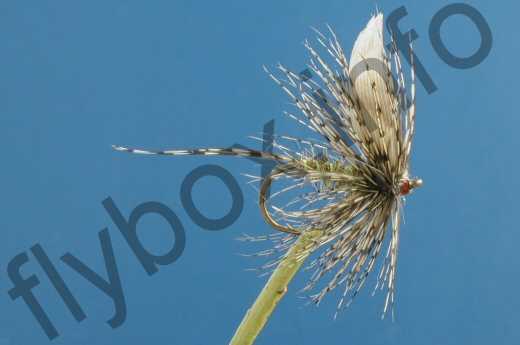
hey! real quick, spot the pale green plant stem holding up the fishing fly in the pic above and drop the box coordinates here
[229,230,321,345]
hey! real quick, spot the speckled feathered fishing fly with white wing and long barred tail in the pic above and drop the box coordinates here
[114,13,422,316]
